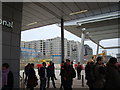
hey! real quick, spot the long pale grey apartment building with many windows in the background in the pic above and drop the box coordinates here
[21,37,93,63]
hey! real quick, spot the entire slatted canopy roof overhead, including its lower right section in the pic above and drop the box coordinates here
[22,0,120,48]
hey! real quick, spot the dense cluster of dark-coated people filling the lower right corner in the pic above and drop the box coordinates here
[85,56,120,90]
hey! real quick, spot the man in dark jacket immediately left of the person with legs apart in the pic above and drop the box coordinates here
[38,62,47,90]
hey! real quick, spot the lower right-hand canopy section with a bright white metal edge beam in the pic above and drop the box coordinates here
[65,12,120,49]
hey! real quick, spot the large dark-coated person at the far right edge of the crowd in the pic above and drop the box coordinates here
[105,57,120,90]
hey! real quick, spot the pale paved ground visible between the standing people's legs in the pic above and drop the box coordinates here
[20,69,89,90]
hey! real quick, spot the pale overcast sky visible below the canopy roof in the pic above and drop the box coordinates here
[21,24,118,57]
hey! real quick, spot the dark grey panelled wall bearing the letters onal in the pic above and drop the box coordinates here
[0,2,23,88]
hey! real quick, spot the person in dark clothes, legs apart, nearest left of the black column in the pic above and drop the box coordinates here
[47,61,56,88]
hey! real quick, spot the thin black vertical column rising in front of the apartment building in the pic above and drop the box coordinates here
[61,18,64,61]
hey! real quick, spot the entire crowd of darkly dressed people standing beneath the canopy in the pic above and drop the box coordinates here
[2,56,120,90]
